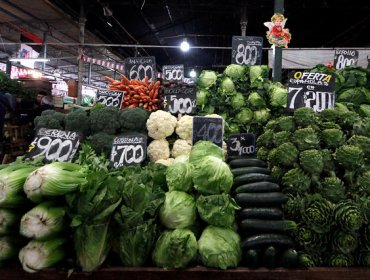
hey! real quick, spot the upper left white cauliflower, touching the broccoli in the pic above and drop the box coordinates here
[146,110,177,140]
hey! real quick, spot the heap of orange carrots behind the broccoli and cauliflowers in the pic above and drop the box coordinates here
[105,74,160,112]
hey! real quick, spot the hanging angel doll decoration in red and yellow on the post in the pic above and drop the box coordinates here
[264,13,292,48]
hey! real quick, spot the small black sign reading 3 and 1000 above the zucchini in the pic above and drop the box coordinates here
[227,133,256,156]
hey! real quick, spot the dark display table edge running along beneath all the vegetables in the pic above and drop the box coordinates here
[0,267,370,280]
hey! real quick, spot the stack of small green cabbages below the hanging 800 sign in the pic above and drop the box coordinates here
[197,64,288,135]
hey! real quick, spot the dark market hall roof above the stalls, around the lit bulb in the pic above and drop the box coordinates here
[0,0,370,81]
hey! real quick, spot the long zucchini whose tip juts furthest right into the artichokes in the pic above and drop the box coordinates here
[240,219,297,233]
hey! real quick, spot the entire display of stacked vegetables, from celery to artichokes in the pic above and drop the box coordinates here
[0,65,370,273]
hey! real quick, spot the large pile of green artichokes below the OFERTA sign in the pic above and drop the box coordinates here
[257,107,370,266]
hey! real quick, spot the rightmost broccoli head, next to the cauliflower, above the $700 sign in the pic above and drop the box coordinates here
[118,108,149,132]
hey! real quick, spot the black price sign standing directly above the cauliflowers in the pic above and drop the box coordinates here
[163,87,197,115]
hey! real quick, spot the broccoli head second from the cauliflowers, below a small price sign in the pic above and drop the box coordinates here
[90,106,120,135]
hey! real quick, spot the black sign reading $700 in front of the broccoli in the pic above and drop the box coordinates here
[110,133,147,168]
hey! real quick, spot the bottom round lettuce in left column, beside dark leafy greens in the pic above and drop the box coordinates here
[153,229,198,268]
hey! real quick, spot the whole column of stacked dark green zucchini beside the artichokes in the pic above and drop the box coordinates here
[229,158,298,268]
